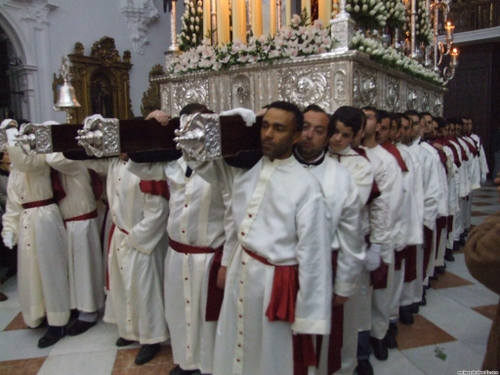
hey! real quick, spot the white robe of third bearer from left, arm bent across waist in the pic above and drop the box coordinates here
[85,158,168,344]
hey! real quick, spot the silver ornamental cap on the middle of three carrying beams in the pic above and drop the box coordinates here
[76,115,120,158]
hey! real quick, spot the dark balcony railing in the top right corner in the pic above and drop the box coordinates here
[450,0,500,32]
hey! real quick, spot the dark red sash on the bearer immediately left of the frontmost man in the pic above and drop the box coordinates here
[169,238,224,322]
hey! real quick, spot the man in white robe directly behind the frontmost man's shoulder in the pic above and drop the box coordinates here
[294,105,364,375]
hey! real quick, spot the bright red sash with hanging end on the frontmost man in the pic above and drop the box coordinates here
[243,248,318,375]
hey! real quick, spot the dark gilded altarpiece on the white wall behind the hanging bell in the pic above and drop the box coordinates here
[52,36,134,123]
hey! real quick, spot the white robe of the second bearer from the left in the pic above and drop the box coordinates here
[46,153,104,313]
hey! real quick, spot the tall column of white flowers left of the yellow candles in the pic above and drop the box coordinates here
[177,0,203,51]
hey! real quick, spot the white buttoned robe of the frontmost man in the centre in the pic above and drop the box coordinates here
[193,156,332,375]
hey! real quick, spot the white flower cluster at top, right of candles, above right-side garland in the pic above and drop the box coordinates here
[345,0,387,30]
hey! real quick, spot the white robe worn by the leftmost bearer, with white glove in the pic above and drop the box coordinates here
[2,147,70,327]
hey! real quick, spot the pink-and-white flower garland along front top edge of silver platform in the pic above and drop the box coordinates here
[166,15,336,74]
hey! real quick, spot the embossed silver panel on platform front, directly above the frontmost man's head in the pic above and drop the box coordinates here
[278,66,330,108]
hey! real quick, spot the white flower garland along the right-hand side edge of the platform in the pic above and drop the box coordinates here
[350,32,444,85]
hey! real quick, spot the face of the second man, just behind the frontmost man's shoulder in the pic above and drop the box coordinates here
[297,111,329,162]
